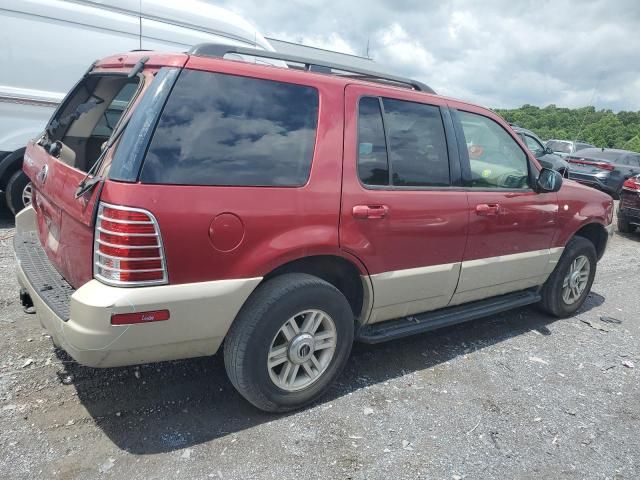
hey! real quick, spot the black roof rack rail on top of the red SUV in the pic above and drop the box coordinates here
[187,43,436,94]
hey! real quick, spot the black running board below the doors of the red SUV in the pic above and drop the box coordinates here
[356,290,541,343]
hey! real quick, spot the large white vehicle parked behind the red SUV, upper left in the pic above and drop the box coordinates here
[0,0,280,214]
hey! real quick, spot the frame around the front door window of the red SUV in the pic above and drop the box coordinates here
[450,107,540,193]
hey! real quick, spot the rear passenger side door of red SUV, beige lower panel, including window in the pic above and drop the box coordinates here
[340,85,468,322]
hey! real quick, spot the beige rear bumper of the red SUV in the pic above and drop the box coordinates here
[16,207,262,367]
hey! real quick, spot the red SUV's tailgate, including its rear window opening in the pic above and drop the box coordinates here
[24,60,162,288]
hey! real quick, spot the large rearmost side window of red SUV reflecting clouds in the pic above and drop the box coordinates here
[140,70,318,186]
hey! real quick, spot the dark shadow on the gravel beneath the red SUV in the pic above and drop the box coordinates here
[57,293,604,454]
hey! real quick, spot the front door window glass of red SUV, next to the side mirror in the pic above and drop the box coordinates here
[458,111,529,189]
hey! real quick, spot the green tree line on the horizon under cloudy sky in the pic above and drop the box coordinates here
[495,105,640,152]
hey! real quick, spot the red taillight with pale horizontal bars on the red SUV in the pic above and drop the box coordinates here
[93,202,168,287]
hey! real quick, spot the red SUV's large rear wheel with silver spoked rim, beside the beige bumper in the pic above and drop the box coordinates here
[224,273,354,412]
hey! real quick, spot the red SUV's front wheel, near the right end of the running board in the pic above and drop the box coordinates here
[540,236,598,318]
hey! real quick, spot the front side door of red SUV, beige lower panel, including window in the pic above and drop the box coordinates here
[451,107,562,305]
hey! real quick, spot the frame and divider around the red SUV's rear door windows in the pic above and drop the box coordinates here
[355,93,464,191]
